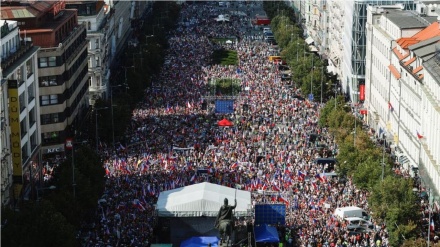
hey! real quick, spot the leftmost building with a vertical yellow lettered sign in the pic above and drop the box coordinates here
[0,18,41,205]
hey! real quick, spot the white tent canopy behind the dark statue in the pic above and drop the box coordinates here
[157,182,251,217]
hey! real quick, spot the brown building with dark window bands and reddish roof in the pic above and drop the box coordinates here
[1,1,89,163]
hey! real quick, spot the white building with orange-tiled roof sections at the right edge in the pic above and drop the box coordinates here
[364,6,440,192]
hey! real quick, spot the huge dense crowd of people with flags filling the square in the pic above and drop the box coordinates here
[85,2,388,247]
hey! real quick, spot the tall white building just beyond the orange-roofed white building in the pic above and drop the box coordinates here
[292,0,416,103]
